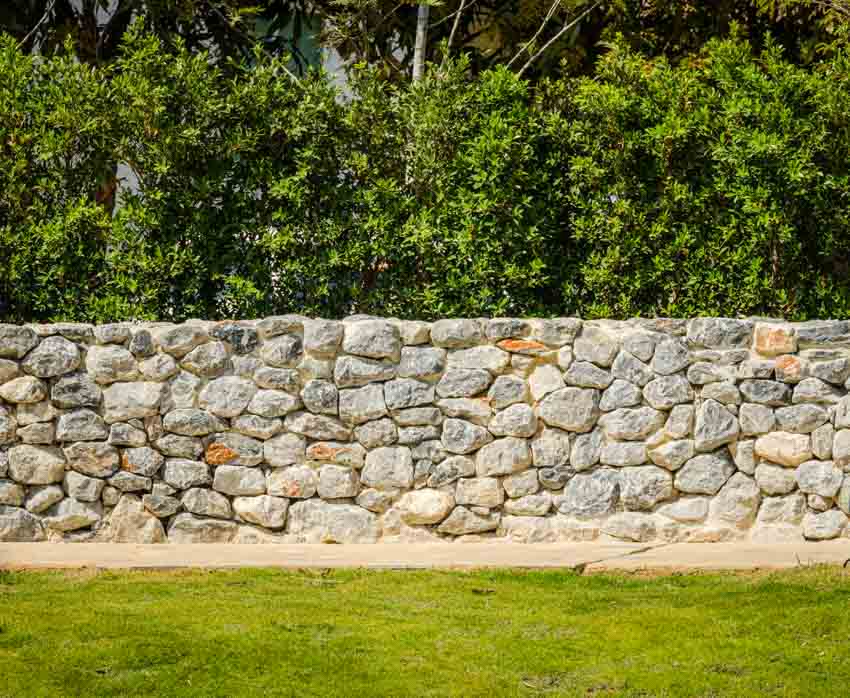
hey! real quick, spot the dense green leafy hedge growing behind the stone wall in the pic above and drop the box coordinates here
[0,31,850,321]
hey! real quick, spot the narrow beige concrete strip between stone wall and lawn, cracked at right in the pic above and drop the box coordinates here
[0,540,850,572]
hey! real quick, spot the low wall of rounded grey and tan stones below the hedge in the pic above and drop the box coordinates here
[0,316,850,543]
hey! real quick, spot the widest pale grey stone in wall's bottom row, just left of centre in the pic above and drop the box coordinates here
[286,499,380,543]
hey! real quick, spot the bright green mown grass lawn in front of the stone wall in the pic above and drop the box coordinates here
[0,568,850,698]
